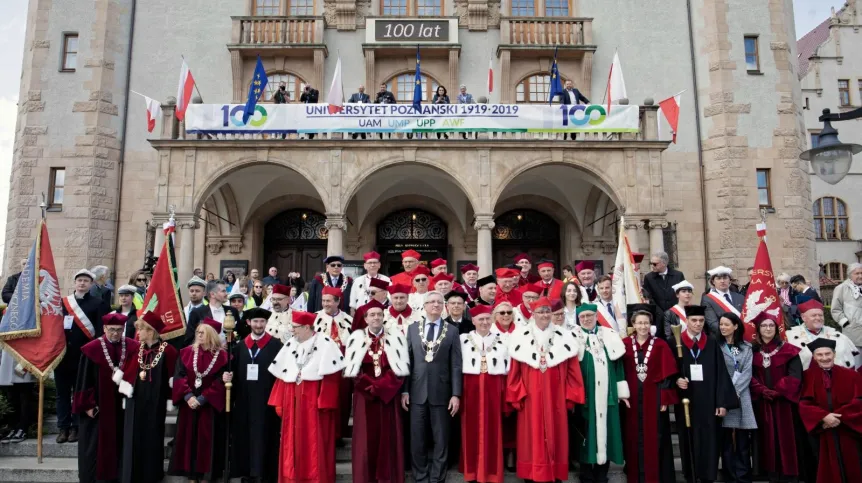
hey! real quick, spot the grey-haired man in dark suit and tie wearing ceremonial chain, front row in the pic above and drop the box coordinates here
[401,292,462,483]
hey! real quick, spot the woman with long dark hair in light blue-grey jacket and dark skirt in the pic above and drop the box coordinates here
[718,312,757,482]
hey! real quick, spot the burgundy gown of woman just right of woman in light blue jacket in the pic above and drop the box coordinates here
[750,339,806,476]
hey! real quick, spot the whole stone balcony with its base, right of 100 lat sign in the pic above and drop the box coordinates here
[498,17,596,58]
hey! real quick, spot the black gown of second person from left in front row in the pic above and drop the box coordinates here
[121,341,177,483]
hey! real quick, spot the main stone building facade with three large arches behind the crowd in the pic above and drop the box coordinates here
[4,0,817,288]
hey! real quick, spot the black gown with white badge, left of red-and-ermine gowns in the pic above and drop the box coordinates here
[230,334,282,481]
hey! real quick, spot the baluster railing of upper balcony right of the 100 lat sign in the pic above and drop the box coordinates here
[500,17,593,46]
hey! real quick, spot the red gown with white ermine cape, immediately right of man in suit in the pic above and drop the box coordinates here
[458,332,514,482]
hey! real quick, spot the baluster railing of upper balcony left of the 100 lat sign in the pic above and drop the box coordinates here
[231,16,324,47]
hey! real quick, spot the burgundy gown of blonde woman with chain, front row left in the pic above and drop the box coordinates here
[168,346,227,480]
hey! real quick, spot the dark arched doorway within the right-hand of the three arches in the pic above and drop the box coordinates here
[492,209,562,270]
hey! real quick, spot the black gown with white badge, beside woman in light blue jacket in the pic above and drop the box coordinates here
[669,331,739,481]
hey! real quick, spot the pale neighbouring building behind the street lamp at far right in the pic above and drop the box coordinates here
[799,0,862,285]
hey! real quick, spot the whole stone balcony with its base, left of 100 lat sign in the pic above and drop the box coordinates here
[227,16,326,57]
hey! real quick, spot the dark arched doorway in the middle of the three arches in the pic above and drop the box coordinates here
[377,209,449,275]
